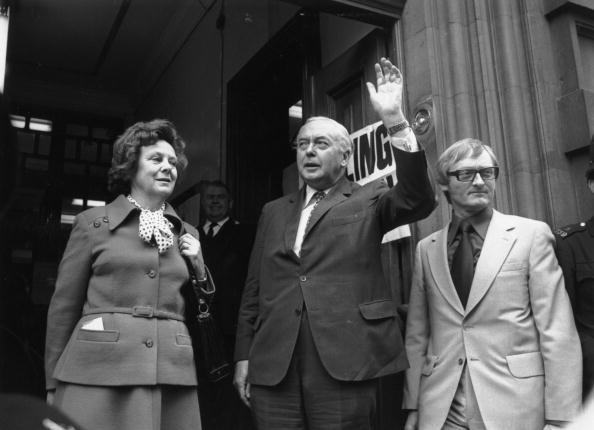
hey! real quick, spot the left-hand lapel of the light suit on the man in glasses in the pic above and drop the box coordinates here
[427,226,464,315]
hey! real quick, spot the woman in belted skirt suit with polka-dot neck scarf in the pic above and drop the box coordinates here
[45,120,206,430]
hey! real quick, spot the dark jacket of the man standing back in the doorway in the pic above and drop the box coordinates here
[198,219,254,338]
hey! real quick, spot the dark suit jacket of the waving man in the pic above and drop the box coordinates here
[235,150,435,385]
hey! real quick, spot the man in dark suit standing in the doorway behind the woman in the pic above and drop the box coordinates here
[198,181,254,430]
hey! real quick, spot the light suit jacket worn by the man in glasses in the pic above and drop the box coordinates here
[404,211,582,430]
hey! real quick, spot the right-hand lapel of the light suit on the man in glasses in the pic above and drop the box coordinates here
[466,211,517,314]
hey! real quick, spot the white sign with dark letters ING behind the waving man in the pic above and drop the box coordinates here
[347,121,410,243]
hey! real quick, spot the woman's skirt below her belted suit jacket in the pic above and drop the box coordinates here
[54,382,202,430]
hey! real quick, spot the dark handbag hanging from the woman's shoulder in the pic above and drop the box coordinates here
[182,223,232,382]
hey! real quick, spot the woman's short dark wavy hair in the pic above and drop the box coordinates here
[107,119,188,194]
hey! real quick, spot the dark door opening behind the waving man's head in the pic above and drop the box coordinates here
[227,11,319,223]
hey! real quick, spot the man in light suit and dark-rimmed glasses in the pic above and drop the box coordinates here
[403,139,582,430]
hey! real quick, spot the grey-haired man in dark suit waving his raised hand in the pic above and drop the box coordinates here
[235,59,435,430]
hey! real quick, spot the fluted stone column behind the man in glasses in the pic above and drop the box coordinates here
[412,0,567,223]
